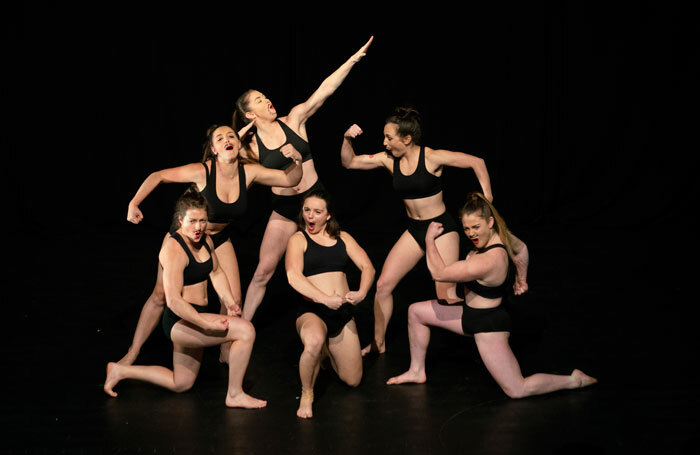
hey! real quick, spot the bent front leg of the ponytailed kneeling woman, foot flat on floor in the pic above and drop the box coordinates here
[386,300,464,384]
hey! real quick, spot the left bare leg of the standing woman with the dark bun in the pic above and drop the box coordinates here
[362,231,424,355]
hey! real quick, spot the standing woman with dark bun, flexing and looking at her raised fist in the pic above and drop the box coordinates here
[340,108,492,354]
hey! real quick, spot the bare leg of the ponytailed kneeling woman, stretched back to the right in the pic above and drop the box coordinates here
[474,332,598,398]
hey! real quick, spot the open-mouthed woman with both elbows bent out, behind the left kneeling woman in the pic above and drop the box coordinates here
[119,125,303,365]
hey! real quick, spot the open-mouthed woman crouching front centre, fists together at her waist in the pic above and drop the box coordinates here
[285,190,374,418]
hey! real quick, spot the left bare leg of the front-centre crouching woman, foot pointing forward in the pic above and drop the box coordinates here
[296,313,327,419]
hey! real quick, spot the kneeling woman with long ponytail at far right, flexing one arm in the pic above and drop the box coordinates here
[387,193,597,398]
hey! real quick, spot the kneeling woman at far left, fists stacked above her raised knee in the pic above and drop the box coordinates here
[104,189,267,408]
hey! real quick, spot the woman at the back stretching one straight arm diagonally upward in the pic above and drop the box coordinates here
[234,38,372,320]
